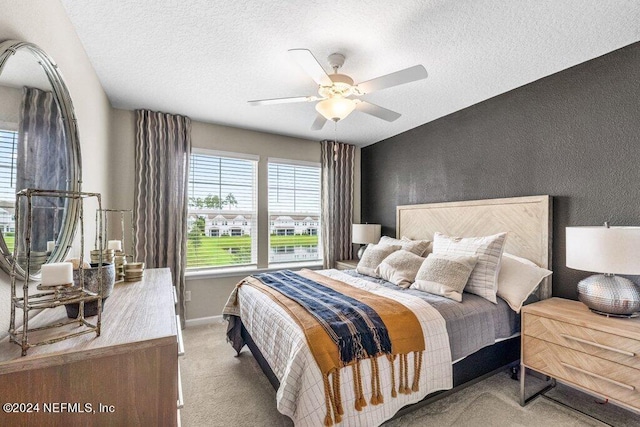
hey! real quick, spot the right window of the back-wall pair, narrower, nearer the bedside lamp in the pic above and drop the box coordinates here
[268,159,322,263]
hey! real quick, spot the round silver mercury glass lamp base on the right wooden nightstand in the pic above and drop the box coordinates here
[578,274,640,317]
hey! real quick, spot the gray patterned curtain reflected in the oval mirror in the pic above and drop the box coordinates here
[16,86,69,252]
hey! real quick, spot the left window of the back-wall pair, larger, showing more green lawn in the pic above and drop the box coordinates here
[187,150,258,268]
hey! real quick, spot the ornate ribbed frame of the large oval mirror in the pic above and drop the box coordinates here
[0,40,82,279]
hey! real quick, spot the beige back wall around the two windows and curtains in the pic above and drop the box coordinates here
[111,110,360,319]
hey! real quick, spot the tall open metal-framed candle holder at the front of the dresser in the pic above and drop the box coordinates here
[9,188,104,356]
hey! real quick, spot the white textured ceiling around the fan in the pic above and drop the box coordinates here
[61,0,640,146]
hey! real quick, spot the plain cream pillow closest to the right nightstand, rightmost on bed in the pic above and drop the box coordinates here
[498,252,553,313]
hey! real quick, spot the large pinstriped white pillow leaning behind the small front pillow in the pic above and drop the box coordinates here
[433,233,507,304]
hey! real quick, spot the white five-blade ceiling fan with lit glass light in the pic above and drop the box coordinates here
[249,49,427,130]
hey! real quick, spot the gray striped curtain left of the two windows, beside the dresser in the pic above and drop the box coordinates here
[133,110,191,327]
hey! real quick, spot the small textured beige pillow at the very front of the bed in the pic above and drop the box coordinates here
[411,254,478,302]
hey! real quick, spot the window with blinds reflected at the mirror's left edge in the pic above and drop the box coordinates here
[0,129,18,250]
